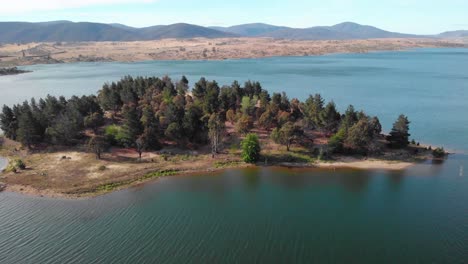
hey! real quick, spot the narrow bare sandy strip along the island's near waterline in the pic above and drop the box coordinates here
[0,154,427,200]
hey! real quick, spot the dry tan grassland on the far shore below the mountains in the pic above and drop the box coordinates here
[0,38,468,67]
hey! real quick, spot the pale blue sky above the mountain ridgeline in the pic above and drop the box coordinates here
[0,0,468,34]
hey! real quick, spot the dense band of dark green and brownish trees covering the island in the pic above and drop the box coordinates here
[0,76,410,161]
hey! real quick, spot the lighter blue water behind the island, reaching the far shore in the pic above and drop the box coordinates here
[0,49,468,151]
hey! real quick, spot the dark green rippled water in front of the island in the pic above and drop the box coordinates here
[0,156,468,263]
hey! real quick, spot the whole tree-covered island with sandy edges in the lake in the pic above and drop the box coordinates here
[0,76,445,197]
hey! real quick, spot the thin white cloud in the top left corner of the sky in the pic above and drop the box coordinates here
[0,0,158,15]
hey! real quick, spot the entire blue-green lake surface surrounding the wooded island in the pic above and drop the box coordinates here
[0,49,468,263]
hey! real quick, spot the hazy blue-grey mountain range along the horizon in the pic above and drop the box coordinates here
[0,21,468,43]
